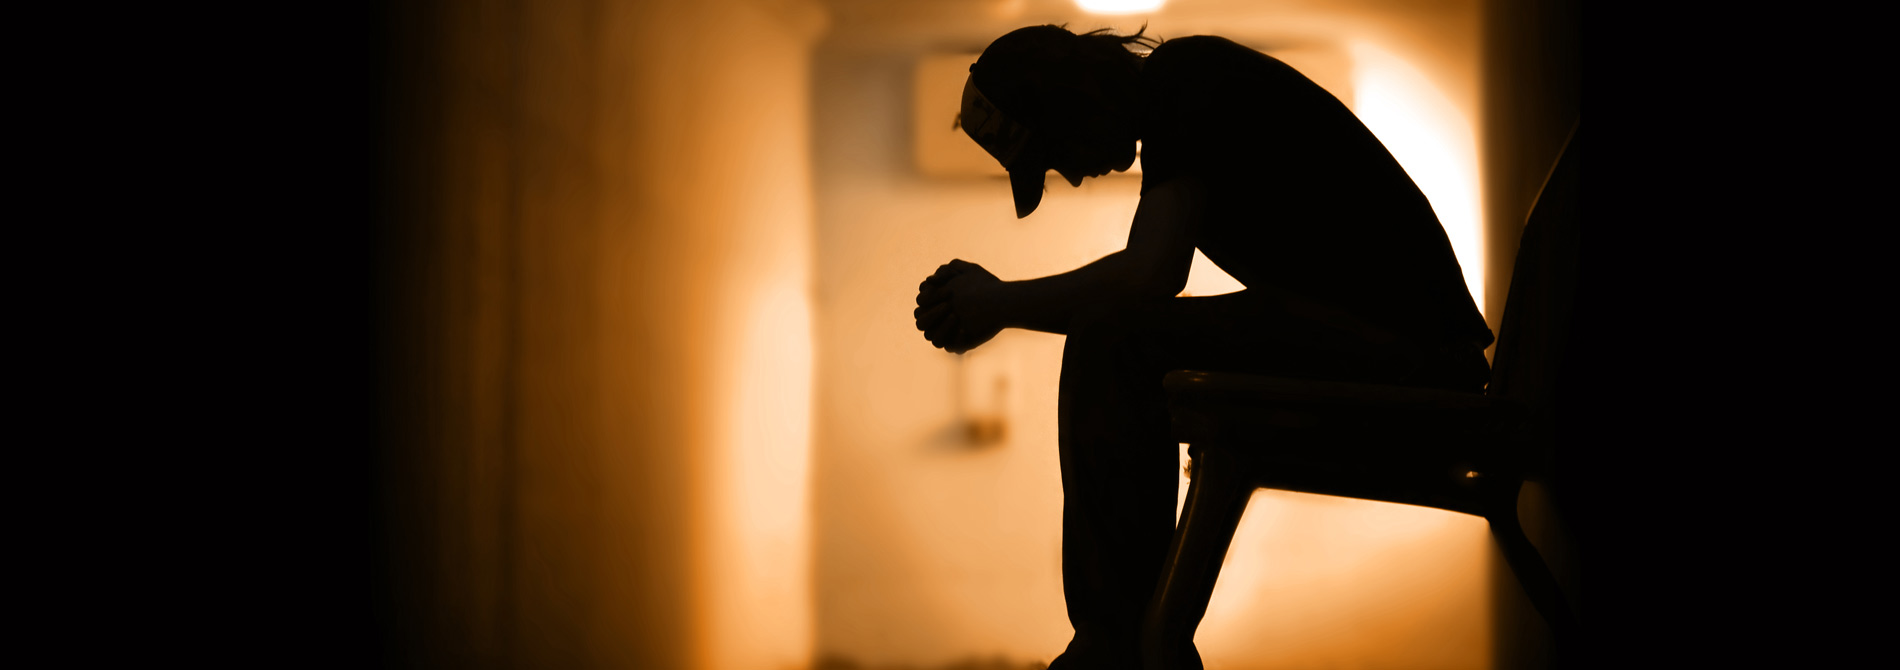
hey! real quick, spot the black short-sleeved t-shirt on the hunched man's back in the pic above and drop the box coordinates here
[1140,36,1492,347]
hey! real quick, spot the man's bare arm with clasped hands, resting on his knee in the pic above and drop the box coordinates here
[916,177,1207,353]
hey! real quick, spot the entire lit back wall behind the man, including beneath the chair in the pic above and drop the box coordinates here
[813,2,1492,668]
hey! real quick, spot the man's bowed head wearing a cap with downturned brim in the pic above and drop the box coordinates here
[960,25,1157,218]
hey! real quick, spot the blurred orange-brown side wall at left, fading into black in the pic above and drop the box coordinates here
[380,0,823,668]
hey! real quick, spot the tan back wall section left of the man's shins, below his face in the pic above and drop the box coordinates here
[813,32,1140,668]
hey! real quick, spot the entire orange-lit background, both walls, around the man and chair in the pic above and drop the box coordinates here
[384,0,1537,670]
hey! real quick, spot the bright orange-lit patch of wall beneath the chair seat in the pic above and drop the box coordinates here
[1195,490,1492,668]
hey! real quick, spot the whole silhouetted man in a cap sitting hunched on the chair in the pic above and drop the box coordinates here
[916,27,1492,670]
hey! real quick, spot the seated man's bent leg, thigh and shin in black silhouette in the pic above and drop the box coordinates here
[1051,292,1406,670]
